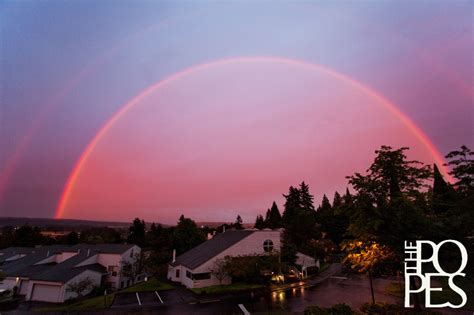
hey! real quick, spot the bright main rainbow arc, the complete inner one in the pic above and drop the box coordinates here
[55,56,452,218]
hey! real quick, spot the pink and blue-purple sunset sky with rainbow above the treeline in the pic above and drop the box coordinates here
[0,0,474,224]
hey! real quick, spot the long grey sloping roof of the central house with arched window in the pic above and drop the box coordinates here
[171,230,255,269]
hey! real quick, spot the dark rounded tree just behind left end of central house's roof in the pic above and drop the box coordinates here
[173,215,206,255]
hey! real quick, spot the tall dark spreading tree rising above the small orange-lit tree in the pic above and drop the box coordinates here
[347,146,432,254]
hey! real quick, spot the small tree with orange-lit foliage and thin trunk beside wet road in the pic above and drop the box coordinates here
[343,240,394,304]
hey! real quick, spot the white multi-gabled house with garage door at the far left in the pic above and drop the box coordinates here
[0,244,141,303]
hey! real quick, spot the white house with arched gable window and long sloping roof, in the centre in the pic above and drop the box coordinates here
[168,229,281,288]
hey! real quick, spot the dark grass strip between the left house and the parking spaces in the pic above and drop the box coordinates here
[35,278,173,312]
